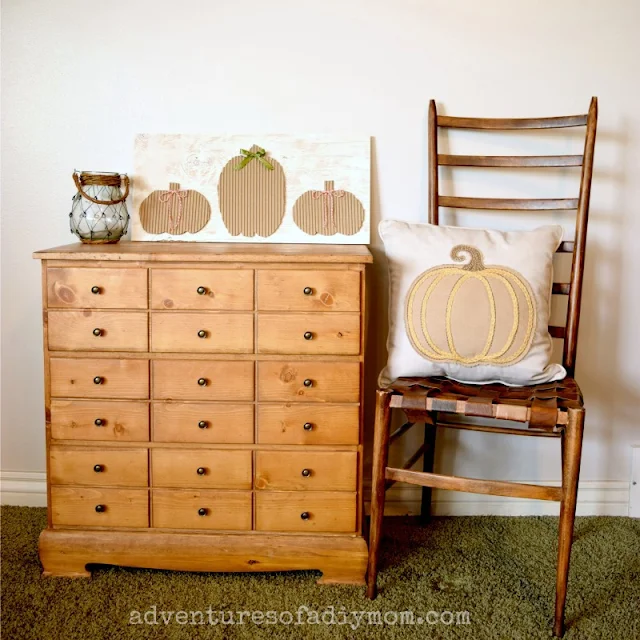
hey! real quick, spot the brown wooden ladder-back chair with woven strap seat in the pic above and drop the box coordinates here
[367,98,597,636]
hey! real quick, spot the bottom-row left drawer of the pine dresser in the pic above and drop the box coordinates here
[51,487,149,527]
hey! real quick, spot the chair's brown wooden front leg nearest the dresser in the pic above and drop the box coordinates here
[367,389,392,599]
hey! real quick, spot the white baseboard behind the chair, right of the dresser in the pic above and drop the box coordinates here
[365,481,629,516]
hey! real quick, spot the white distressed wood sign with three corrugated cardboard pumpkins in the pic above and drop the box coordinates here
[131,134,371,244]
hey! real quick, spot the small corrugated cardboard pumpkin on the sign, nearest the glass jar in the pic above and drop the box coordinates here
[140,182,211,236]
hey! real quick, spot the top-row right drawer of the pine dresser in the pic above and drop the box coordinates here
[257,269,360,312]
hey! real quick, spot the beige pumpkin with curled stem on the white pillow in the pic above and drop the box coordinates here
[405,245,536,366]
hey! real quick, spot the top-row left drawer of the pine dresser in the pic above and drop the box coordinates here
[47,267,147,309]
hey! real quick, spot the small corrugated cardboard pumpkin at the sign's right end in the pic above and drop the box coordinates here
[293,180,364,236]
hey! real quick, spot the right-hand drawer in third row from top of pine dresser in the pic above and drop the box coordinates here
[258,360,360,402]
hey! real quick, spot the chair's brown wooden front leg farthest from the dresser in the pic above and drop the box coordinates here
[553,410,584,637]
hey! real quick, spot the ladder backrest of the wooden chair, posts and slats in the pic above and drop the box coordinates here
[427,98,598,375]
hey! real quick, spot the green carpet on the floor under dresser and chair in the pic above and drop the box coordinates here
[1,507,640,640]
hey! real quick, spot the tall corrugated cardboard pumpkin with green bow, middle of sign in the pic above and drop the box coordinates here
[218,145,286,238]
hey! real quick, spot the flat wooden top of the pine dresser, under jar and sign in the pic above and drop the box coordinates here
[33,242,373,264]
